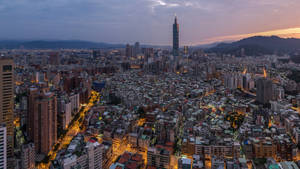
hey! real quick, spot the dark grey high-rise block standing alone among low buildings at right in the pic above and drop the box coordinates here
[256,78,272,104]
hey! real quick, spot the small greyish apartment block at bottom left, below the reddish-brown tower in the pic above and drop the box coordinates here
[21,143,35,169]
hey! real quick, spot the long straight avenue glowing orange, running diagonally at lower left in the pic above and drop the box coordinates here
[37,91,100,169]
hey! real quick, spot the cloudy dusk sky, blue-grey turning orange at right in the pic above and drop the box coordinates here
[0,0,300,45]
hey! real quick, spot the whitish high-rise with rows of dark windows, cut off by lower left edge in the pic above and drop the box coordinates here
[0,124,7,169]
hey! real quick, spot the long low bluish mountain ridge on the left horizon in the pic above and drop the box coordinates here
[0,40,125,49]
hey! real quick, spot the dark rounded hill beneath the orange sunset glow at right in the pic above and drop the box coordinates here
[208,36,300,55]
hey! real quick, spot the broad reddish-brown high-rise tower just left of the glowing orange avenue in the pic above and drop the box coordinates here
[27,88,57,154]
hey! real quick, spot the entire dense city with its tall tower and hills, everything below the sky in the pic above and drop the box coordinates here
[0,1,300,169]
